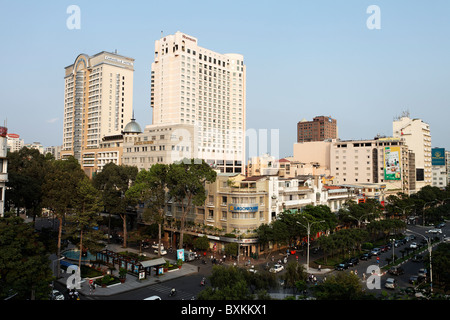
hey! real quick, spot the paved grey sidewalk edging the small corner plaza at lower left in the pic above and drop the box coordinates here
[57,244,198,297]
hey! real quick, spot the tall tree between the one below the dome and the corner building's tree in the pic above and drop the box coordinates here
[126,163,169,256]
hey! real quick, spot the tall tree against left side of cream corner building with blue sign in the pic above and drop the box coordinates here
[167,159,217,248]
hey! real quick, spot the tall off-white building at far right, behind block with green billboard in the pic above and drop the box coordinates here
[392,115,432,191]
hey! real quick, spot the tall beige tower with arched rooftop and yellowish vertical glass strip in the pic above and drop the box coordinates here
[61,51,134,168]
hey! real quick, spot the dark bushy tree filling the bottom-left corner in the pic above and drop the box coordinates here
[0,214,53,300]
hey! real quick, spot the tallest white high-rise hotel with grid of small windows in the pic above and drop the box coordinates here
[151,31,246,172]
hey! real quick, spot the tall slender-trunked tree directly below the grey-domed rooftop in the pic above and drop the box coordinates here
[93,162,138,248]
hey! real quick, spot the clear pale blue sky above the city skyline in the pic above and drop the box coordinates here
[0,0,450,156]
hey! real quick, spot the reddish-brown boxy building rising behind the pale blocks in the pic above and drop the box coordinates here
[297,116,338,142]
